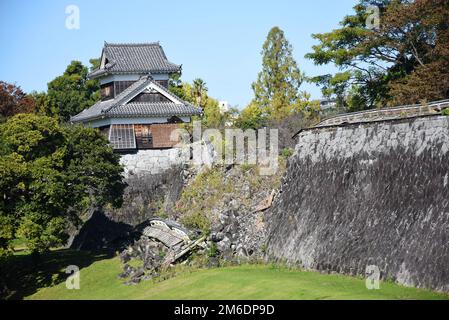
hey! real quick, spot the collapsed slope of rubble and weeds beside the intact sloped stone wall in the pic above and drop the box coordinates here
[178,163,285,261]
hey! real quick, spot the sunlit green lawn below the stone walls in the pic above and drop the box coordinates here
[22,252,449,300]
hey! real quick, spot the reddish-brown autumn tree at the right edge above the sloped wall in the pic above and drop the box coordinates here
[387,0,449,104]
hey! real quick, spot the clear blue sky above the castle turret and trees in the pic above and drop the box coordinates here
[0,0,356,108]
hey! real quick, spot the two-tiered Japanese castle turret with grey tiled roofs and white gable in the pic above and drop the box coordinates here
[70,43,202,152]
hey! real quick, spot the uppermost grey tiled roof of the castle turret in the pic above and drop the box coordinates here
[89,42,181,78]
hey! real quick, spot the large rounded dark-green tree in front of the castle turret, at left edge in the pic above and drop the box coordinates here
[0,114,125,254]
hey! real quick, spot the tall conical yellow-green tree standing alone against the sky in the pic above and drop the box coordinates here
[252,27,303,117]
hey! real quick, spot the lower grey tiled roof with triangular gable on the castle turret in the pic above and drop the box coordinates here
[70,76,202,122]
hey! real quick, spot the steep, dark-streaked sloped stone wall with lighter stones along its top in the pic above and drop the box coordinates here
[267,116,449,291]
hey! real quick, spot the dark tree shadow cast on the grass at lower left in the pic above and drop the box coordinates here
[0,249,113,300]
